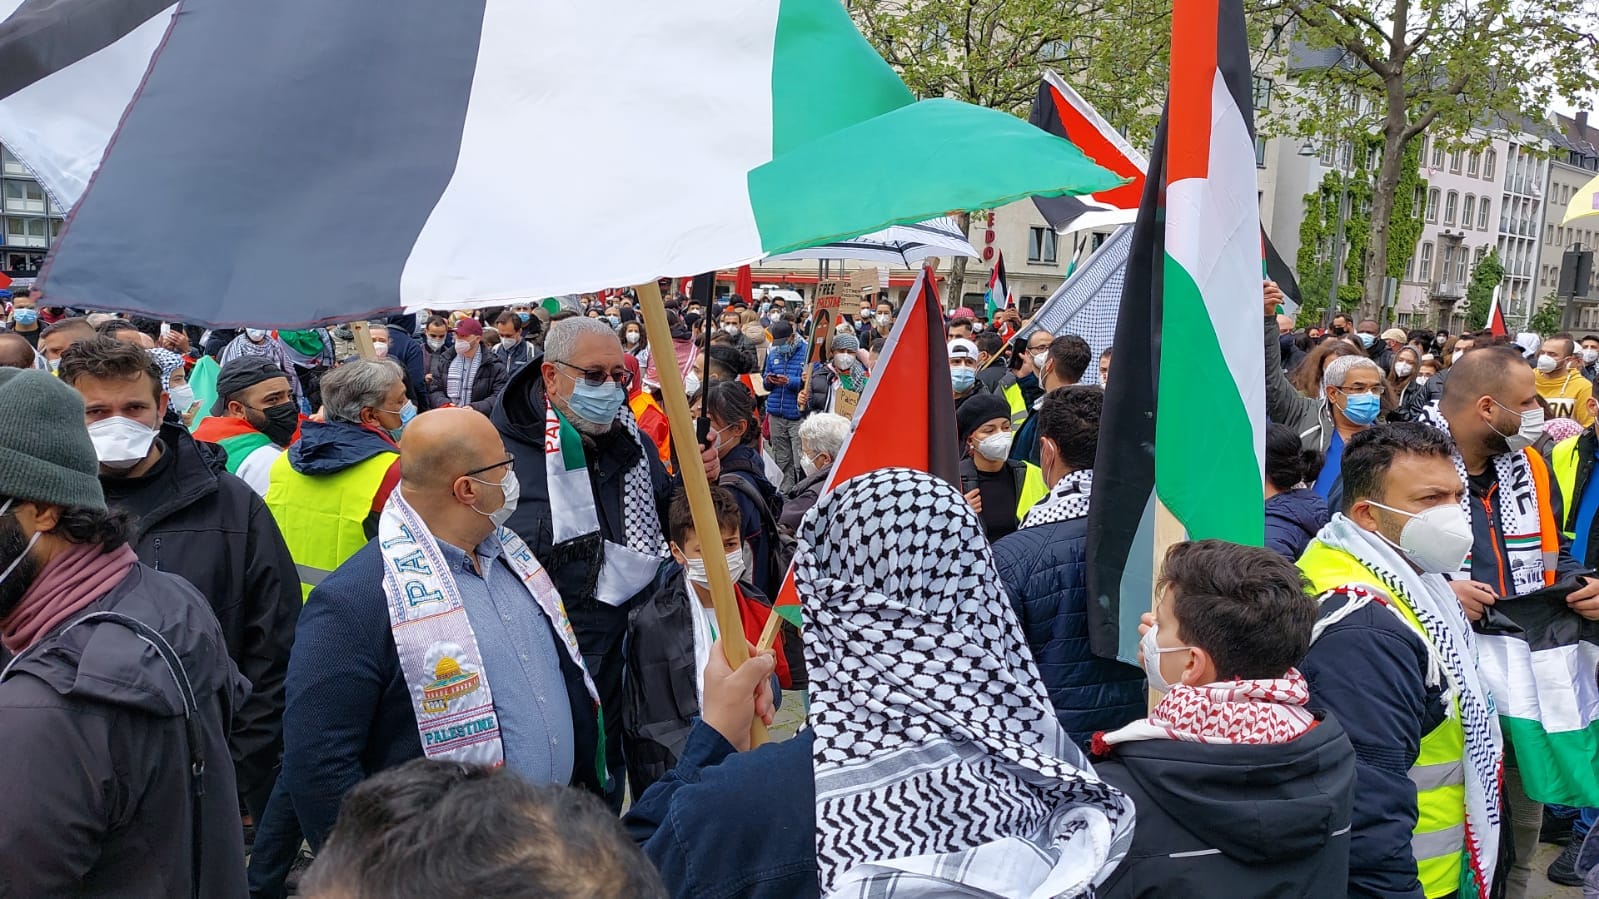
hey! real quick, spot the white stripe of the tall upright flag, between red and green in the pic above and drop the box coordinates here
[1166,70,1266,472]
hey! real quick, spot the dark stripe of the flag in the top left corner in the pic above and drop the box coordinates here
[0,0,176,99]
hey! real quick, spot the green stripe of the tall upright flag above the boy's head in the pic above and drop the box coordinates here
[1154,254,1265,545]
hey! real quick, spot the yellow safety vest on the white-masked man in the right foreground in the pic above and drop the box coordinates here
[1298,541,1471,899]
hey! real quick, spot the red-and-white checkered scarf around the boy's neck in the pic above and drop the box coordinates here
[1094,669,1316,755]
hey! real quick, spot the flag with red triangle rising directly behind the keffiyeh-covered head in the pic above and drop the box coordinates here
[772,269,959,625]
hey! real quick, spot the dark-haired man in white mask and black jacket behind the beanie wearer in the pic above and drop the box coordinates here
[59,336,301,838]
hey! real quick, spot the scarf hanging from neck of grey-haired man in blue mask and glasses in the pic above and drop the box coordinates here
[544,398,668,606]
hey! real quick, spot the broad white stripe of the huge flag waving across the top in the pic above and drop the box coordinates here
[400,0,773,303]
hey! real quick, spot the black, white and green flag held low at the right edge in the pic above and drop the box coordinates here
[1477,590,1599,808]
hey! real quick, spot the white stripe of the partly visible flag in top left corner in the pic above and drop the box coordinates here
[0,0,176,203]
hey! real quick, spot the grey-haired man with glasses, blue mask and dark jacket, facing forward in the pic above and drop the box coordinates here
[489,318,700,808]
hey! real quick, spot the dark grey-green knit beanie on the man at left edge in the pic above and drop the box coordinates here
[0,368,106,512]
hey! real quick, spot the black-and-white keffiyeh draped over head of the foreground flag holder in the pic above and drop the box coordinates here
[795,469,1132,899]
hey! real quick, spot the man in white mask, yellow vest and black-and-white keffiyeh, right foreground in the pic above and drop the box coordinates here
[1298,422,1509,899]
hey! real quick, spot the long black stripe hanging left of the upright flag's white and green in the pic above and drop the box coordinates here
[1087,112,1166,661]
